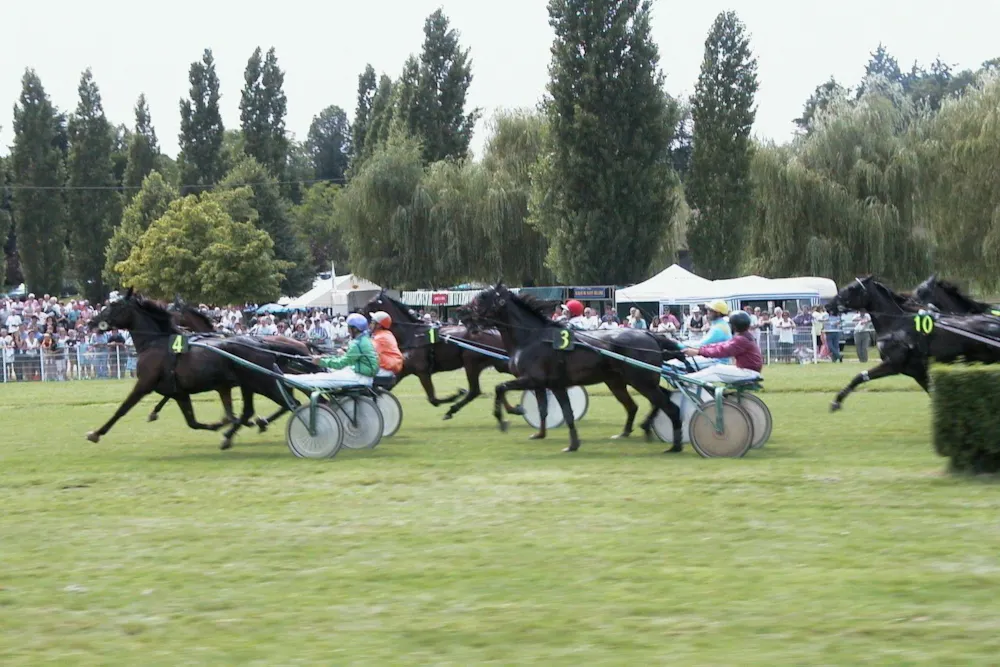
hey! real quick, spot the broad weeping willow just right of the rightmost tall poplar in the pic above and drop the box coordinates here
[744,81,930,286]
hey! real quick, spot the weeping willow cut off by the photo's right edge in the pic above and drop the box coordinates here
[914,73,1000,289]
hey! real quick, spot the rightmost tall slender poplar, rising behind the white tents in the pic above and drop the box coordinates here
[687,12,757,278]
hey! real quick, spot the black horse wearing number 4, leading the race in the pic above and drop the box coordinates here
[87,288,321,449]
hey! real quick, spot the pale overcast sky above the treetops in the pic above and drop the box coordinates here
[0,0,1000,162]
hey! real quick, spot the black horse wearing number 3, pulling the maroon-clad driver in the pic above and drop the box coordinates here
[468,284,683,453]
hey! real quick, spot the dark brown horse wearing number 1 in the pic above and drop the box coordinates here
[361,290,524,420]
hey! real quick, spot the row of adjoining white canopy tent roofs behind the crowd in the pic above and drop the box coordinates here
[615,264,837,308]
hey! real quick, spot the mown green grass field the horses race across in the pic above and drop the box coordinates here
[0,363,1000,666]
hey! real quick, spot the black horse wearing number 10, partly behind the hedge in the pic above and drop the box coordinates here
[827,276,1000,412]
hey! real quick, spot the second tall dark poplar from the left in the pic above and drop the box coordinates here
[66,69,121,303]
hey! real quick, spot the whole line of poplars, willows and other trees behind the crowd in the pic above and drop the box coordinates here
[0,0,1000,303]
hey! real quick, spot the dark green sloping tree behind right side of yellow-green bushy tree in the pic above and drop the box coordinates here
[221,156,315,295]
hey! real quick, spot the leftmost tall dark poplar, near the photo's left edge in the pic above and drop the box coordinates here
[10,69,66,294]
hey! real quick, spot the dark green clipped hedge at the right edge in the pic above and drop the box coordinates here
[931,365,1000,474]
